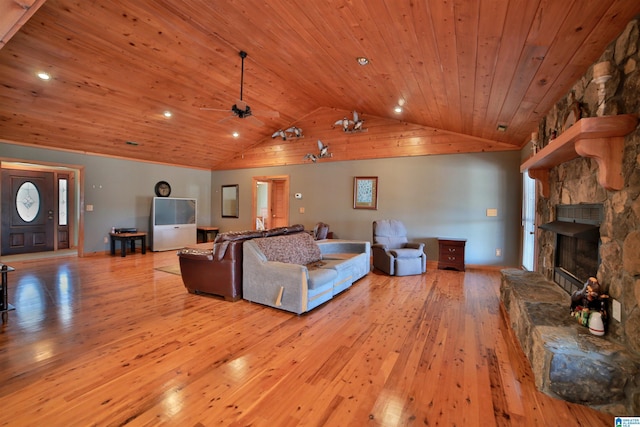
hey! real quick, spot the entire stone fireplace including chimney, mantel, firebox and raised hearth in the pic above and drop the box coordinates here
[512,18,640,415]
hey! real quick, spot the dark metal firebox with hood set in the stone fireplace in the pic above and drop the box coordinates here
[540,204,603,294]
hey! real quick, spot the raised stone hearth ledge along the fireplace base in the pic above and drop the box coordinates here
[500,268,640,415]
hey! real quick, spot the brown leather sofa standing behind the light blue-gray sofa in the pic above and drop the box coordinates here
[178,224,304,301]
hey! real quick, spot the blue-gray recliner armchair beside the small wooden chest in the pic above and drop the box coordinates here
[371,219,427,276]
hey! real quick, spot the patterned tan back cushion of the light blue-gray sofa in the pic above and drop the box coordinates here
[253,233,322,265]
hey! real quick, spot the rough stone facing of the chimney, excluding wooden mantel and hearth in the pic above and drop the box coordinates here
[525,18,640,364]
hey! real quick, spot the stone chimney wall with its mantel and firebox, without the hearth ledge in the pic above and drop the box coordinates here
[521,18,640,414]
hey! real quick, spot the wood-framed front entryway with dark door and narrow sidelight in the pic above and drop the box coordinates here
[0,161,82,256]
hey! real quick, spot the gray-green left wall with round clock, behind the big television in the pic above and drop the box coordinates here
[0,142,211,254]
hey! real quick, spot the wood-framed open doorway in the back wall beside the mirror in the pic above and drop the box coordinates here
[252,175,289,230]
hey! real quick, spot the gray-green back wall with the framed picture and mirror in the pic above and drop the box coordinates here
[211,151,522,266]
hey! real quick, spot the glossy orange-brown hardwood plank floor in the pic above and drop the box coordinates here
[0,251,613,427]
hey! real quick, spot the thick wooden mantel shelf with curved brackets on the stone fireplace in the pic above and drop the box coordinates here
[520,114,638,197]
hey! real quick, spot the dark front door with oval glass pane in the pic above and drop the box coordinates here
[2,169,56,255]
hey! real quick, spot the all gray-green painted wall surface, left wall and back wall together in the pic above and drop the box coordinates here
[0,143,521,266]
